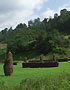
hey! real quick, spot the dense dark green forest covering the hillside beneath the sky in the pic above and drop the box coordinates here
[0,9,70,54]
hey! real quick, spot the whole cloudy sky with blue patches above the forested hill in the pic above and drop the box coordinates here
[0,0,70,30]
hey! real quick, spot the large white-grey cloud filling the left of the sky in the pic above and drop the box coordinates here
[0,0,48,29]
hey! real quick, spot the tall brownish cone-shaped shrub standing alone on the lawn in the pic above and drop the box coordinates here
[4,51,13,76]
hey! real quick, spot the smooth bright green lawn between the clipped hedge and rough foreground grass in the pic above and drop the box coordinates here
[0,62,70,90]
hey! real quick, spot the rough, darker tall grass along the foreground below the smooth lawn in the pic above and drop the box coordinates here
[0,74,70,90]
